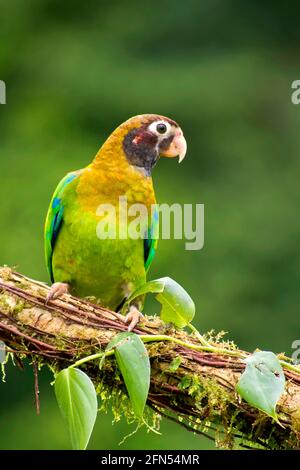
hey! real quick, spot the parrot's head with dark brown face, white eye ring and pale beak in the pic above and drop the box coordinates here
[99,114,187,176]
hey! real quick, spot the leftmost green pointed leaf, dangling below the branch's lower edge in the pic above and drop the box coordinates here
[55,368,98,450]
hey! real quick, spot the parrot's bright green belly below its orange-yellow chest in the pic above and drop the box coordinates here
[53,198,146,309]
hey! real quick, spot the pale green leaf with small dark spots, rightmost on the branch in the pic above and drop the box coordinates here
[236,351,285,420]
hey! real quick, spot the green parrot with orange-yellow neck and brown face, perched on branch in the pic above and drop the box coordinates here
[44,114,187,331]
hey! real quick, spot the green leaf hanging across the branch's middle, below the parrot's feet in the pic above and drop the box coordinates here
[107,332,151,419]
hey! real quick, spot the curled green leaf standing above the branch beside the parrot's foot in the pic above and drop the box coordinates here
[124,277,195,328]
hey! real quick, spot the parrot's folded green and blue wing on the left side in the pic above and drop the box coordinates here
[45,172,80,282]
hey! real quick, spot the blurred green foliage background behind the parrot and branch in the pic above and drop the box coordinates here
[0,0,300,449]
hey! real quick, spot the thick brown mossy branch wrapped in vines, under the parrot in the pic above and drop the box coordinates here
[0,268,300,449]
